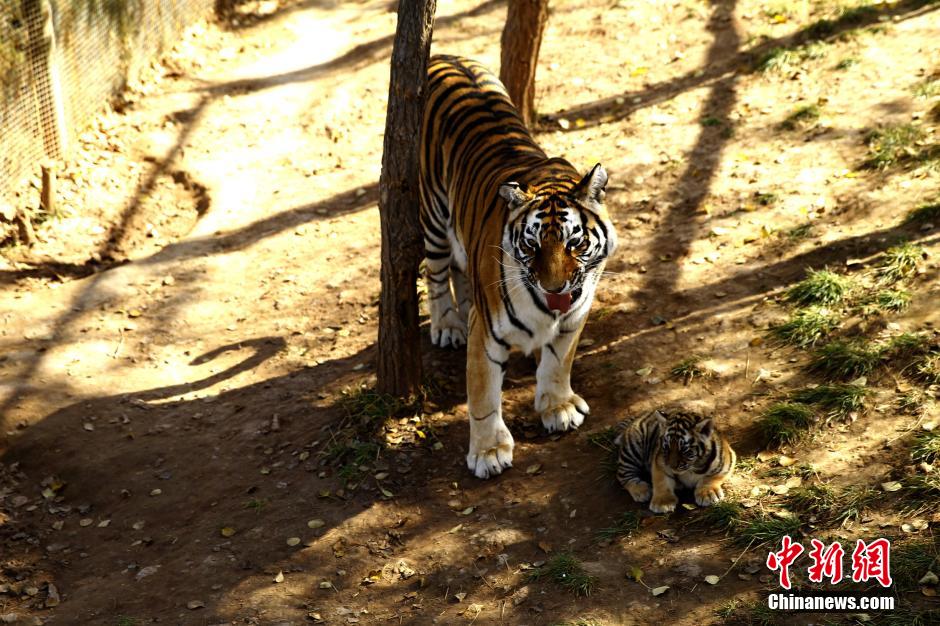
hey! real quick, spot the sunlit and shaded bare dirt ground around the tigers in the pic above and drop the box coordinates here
[0,0,940,626]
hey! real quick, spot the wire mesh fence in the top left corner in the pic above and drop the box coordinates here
[0,0,219,209]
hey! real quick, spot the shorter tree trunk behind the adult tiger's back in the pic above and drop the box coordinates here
[499,0,548,128]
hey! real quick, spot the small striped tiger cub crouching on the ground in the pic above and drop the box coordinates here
[614,410,737,513]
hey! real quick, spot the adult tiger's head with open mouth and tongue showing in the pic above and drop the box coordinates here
[499,164,617,313]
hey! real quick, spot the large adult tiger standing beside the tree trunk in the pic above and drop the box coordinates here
[420,56,616,478]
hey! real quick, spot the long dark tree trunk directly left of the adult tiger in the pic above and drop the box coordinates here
[378,0,437,397]
